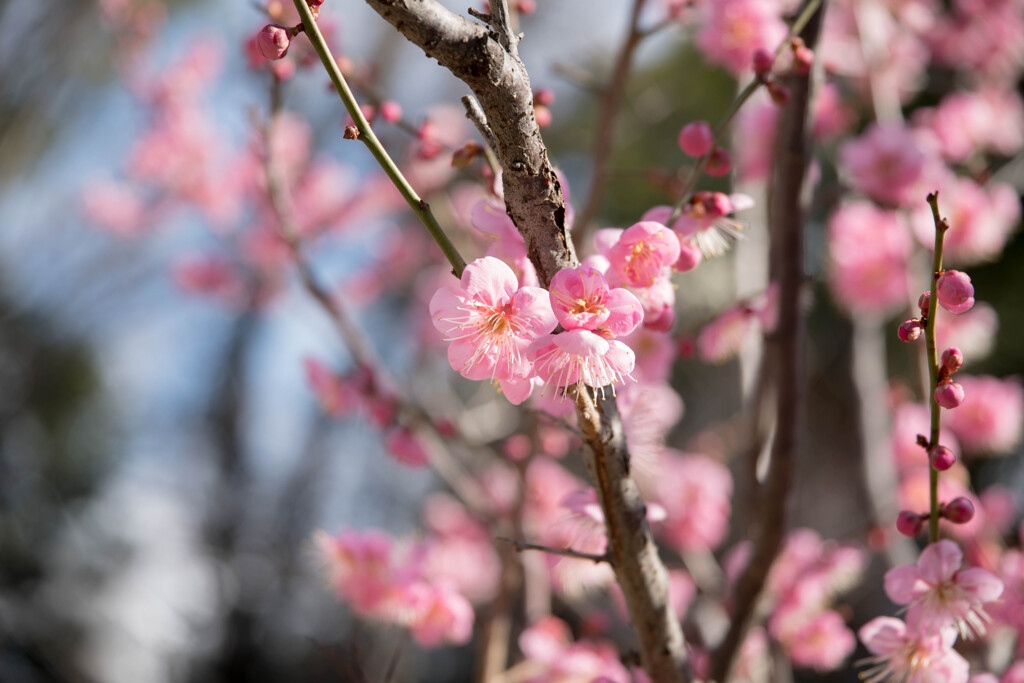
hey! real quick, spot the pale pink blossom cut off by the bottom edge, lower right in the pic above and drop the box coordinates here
[857,616,969,683]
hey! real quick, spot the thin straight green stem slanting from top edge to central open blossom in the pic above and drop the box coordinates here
[293,0,466,278]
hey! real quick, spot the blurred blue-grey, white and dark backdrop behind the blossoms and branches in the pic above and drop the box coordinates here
[0,0,1024,683]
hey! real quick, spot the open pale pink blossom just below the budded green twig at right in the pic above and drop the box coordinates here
[885,540,1002,638]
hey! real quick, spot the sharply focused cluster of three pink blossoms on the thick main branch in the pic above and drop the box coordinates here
[430,256,643,404]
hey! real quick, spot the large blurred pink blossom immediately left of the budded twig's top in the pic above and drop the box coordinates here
[828,202,911,313]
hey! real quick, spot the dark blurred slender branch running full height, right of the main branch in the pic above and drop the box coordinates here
[711,0,824,681]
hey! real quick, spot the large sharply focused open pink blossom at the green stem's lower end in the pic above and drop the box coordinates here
[430,256,557,403]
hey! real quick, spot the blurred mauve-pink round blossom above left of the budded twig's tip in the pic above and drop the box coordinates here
[839,124,929,206]
